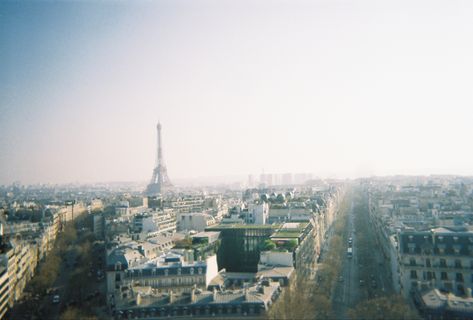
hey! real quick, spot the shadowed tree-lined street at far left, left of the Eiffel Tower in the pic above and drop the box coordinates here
[11,215,105,319]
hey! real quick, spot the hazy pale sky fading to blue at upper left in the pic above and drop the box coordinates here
[0,0,473,184]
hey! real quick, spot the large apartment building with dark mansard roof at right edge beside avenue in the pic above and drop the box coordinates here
[398,227,473,297]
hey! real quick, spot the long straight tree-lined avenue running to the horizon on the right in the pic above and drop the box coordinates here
[268,189,418,319]
